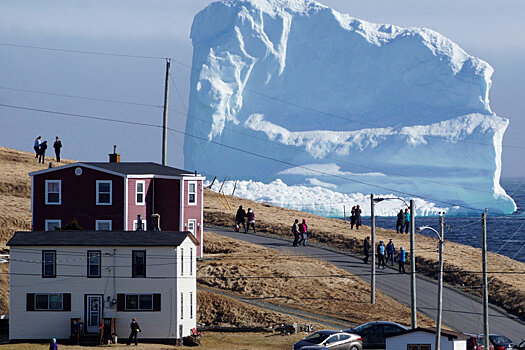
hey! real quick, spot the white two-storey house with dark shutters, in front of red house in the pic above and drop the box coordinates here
[8,231,198,340]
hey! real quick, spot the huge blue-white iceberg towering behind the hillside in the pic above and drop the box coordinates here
[184,0,516,215]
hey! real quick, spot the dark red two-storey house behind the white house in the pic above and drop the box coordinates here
[29,155,205,256]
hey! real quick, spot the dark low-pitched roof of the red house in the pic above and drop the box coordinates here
[29,162,204,177]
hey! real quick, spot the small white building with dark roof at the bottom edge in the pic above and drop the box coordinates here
[386,328,468,350]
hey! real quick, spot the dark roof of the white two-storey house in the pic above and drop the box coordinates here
[7,231,199,247]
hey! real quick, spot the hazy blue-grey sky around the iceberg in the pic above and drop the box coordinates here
[0,0,525,176]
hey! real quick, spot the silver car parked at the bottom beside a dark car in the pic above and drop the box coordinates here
[293,329,363,350]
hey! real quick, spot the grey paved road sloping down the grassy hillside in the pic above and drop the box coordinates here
[206,227,525,343]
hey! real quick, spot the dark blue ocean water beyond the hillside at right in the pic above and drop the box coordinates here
[363,178,525,262]
